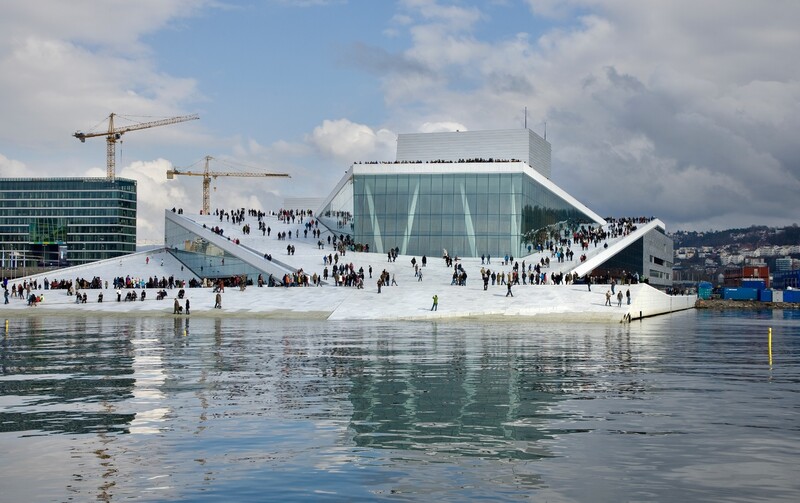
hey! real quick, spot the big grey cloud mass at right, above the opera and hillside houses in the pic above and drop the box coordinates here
[384,0,800,231]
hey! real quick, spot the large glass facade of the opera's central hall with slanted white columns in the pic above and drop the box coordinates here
[320,169,595,257]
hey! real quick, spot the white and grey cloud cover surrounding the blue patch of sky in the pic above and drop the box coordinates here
[0,0,800,252]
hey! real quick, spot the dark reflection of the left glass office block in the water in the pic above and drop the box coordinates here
[0,317,134,434]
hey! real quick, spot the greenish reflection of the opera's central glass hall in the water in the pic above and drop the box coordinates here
[350,336,561,459]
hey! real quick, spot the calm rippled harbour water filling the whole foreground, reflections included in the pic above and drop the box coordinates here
[0,311,800,502]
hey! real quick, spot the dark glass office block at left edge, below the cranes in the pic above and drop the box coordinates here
[0,178,136,268]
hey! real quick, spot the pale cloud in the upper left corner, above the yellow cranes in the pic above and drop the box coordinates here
[0,0,206,154]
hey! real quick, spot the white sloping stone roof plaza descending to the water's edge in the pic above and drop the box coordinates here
[2,215,695,323]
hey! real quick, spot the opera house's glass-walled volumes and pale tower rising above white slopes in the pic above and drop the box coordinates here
[165,129,673,288]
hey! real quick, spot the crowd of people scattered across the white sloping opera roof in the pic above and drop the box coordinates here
[3,208,650,312]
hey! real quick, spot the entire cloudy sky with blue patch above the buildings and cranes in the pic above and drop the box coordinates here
[0,0,800,244]
